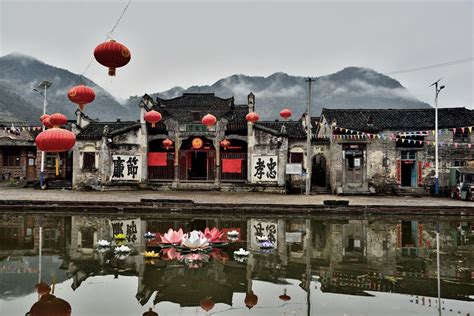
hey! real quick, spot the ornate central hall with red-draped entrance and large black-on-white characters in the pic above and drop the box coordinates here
[73,93,322,192]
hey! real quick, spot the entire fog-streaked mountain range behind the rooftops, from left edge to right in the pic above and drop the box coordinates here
[0,53,429,124]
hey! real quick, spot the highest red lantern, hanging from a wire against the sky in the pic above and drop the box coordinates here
[94,40,131,76]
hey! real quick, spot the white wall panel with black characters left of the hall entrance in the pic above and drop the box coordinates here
[110,155,142,181]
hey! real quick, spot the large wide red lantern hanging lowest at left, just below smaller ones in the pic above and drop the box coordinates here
[35,128,76,153]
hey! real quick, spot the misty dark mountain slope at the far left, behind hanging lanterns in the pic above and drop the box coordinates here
[0,53,130,124]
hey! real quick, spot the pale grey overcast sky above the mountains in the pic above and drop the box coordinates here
[0,0,474,108]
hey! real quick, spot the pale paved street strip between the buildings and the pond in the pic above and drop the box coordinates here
[0,187,474,208]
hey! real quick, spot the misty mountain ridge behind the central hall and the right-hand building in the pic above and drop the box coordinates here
[136,67,430,119]
